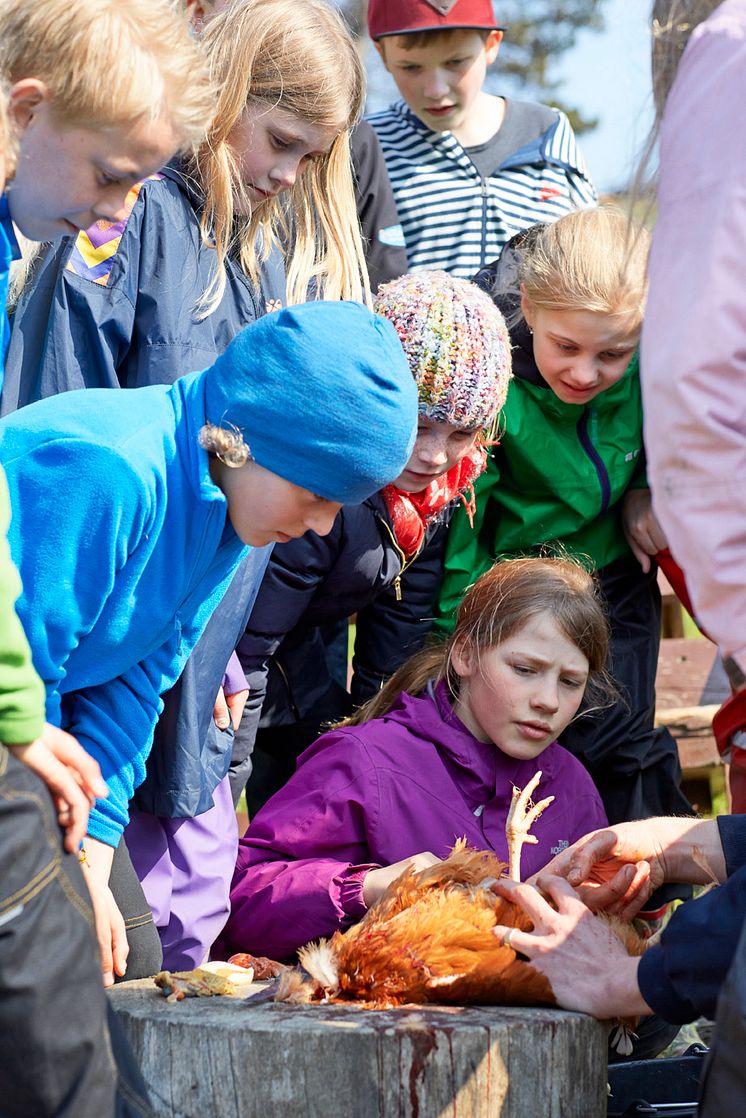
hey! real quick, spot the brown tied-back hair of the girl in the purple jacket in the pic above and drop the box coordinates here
[339,558,615,726]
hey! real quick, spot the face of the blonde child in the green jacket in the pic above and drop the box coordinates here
[521,296,640,404]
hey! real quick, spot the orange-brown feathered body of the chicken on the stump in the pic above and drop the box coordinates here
[276,841,644,1051]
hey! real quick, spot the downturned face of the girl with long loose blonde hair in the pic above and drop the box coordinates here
[228,102,340,212]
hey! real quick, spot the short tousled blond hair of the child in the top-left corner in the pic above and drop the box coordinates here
[0,0,214,150]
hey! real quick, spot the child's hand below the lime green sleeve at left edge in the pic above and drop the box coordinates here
[8,722,108,853]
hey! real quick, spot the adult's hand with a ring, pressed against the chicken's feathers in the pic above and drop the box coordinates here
[492,874,652,1021]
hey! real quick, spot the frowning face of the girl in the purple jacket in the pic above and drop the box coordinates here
[453,614,588,760]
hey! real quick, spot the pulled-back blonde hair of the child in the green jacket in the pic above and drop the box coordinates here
[518,206,650,333]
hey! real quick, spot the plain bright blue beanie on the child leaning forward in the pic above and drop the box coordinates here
[205,301,417,504]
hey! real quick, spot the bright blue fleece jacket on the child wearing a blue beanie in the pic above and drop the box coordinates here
[0,373,248,846]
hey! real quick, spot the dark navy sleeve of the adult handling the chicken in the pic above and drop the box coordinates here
[638,815,746,1024]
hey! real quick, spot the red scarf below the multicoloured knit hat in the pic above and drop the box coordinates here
[381,442,487,559]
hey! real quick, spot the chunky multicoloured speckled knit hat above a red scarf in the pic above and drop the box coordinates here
[375,272,511,429]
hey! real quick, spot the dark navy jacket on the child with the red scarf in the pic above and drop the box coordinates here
[238,493,455,748]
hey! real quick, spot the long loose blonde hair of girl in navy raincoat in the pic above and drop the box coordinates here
[189,0,370,314]
